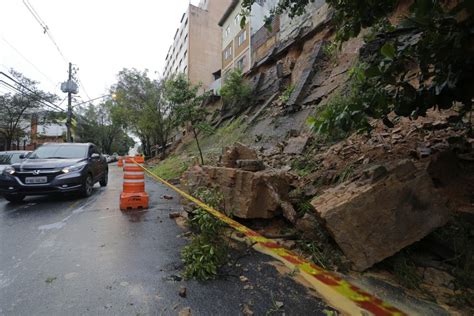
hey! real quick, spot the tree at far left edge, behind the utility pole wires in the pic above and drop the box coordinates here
[0,69,56,150]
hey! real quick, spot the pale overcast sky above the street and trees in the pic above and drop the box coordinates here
[0,0,199,107]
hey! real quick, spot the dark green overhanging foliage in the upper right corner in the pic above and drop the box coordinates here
[306,0,474,137]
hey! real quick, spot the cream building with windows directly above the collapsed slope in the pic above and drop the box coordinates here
[219,0,277,77]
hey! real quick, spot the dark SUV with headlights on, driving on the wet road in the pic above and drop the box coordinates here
[0,143,109,202]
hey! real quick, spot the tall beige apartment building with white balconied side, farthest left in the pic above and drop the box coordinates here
[163,0,231,89]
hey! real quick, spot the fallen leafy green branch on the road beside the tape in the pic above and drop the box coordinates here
[181,188,228,280]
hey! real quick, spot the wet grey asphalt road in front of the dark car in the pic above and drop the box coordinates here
[0,165,330,315]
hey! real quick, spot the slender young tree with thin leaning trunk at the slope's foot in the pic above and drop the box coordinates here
[165,74,211,164]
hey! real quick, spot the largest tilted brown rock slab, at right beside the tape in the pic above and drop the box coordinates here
[311,160,449,271]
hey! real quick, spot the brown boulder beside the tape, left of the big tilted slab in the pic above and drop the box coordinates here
[181,166,296,222]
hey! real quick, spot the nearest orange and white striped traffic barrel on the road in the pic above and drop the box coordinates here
[120,156,148,211]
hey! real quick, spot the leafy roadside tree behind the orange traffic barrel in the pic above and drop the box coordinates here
[112,69,174,156]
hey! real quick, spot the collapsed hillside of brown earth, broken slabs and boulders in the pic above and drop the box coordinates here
[149,2,474,314]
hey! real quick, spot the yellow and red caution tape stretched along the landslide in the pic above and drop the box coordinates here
[134,161,407,316]
